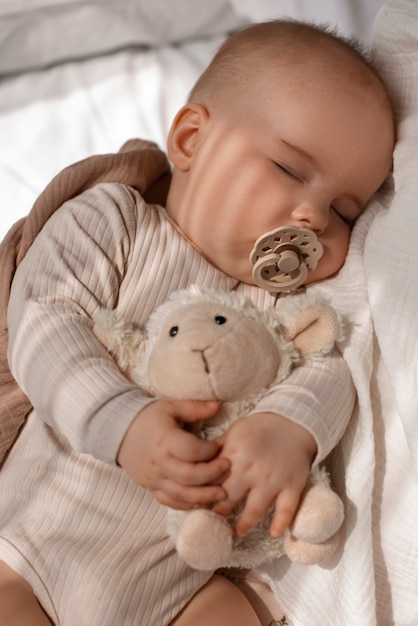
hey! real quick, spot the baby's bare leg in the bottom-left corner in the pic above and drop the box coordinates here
[0,561,52,626]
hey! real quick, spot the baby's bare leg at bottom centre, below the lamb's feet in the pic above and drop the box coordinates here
[170,574,261,626]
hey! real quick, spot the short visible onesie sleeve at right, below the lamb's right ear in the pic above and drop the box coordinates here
[250,350,356,465]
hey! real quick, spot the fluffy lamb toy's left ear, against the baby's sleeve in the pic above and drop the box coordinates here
[93,309,146,373]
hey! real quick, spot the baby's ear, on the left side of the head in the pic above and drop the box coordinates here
[167,102,209,172]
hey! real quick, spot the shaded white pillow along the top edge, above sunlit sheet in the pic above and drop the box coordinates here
[0,0,245,75]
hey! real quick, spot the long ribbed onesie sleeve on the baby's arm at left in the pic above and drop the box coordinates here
[8,184,150,463]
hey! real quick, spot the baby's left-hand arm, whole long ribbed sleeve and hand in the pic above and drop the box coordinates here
[9,185,228,508]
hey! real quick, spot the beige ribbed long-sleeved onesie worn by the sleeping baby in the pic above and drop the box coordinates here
[0,183,354,626]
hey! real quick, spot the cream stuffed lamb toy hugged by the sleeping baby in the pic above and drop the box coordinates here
[94,286,344,570]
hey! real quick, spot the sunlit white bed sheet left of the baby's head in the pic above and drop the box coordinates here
[0,37,222,239]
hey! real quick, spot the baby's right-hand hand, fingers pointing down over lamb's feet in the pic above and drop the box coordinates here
[214,413,316,537]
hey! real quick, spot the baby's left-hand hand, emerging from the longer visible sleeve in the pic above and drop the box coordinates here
[118,400,230,510]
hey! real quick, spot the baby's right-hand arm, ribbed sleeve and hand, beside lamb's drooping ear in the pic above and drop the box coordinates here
[215,351,355,536]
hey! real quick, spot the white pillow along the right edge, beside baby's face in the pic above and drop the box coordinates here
[365,0,418,458]
